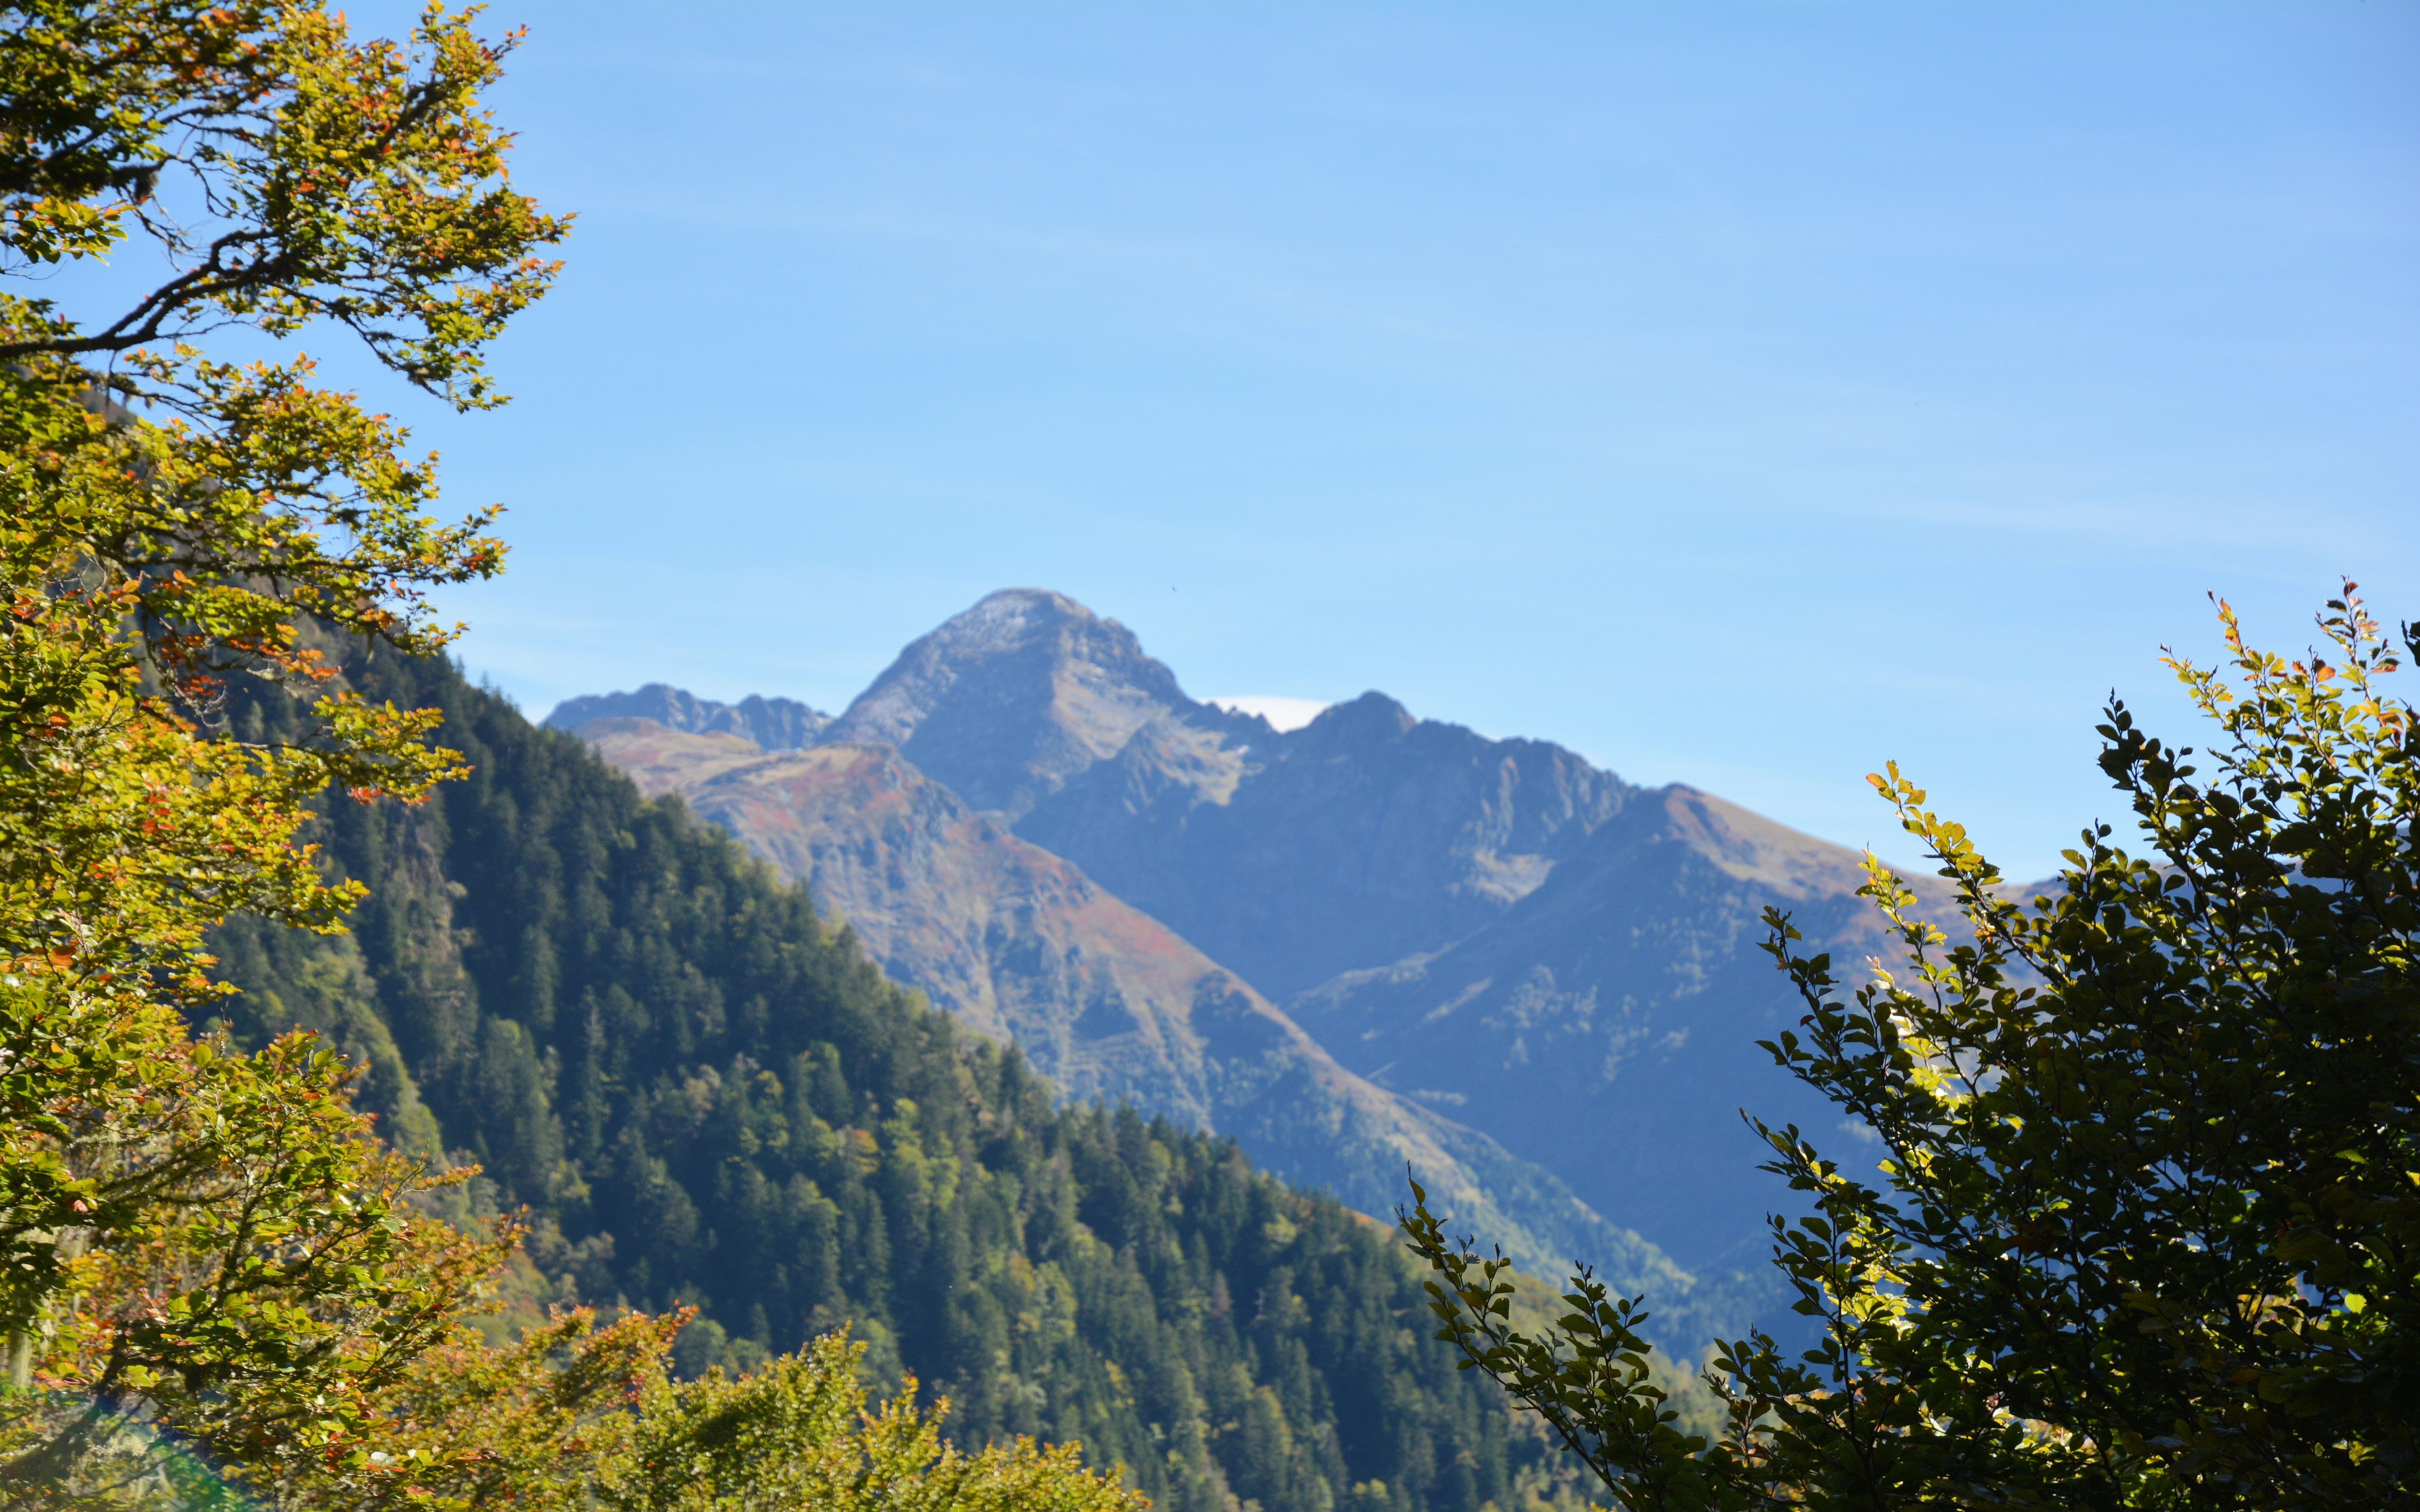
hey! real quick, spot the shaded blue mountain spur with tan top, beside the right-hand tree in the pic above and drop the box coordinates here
[1287,786,1955,1265]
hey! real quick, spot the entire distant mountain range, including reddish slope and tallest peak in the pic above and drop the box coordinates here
[547,590,1946,1306]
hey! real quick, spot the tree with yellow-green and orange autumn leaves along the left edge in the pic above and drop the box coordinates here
[0,0,566,1505]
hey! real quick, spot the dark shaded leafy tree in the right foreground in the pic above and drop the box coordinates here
[1406,583,2420,1510]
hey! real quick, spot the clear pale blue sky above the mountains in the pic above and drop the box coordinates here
[307,0,2420,876]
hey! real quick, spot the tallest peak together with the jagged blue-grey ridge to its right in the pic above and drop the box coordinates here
[823,588,1631,997]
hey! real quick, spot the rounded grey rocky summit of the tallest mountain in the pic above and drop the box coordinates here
[823,588,1195,818]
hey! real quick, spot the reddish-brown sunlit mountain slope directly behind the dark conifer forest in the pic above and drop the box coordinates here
[576,719,1754,1347]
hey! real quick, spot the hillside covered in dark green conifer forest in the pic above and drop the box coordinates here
[215,648,1588,1512]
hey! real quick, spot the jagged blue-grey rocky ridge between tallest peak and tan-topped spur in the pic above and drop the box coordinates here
[1016,692,1634,997]
